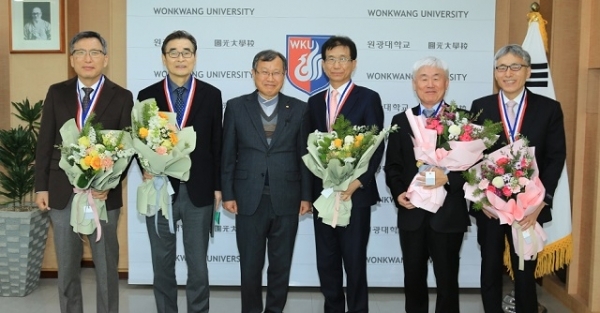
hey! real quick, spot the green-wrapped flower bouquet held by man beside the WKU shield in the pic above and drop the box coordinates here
[302,115,398,228]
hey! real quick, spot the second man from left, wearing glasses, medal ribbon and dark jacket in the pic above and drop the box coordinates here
[138,30,223,313]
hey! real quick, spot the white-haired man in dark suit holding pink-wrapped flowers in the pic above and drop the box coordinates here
[385,57,470,313]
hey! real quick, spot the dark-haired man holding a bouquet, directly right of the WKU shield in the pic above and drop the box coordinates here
[308,36,384,313]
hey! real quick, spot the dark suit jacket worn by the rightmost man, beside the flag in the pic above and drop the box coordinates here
[471,89,567,223]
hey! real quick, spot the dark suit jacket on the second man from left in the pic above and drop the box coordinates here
[138,78,223,207]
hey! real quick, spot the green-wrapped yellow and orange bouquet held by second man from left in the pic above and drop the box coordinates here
[131,99,196,233]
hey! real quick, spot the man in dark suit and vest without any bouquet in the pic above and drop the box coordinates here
[222,50,311,313]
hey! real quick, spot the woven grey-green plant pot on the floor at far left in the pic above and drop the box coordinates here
[0,209,49,297]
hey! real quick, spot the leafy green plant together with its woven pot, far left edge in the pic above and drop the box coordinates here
[0,99,49,296]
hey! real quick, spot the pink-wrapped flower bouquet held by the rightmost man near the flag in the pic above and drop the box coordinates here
[463,139,546,270]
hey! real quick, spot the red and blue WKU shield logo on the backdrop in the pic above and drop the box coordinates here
[286,35,330,96]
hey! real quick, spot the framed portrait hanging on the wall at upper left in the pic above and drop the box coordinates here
[9,0,65,53]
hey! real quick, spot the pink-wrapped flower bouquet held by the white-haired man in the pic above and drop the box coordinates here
[406,102,502,213]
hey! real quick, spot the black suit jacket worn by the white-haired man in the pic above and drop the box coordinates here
[384,106,471,233]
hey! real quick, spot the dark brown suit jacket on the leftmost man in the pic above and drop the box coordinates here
[35,77,133,210]
